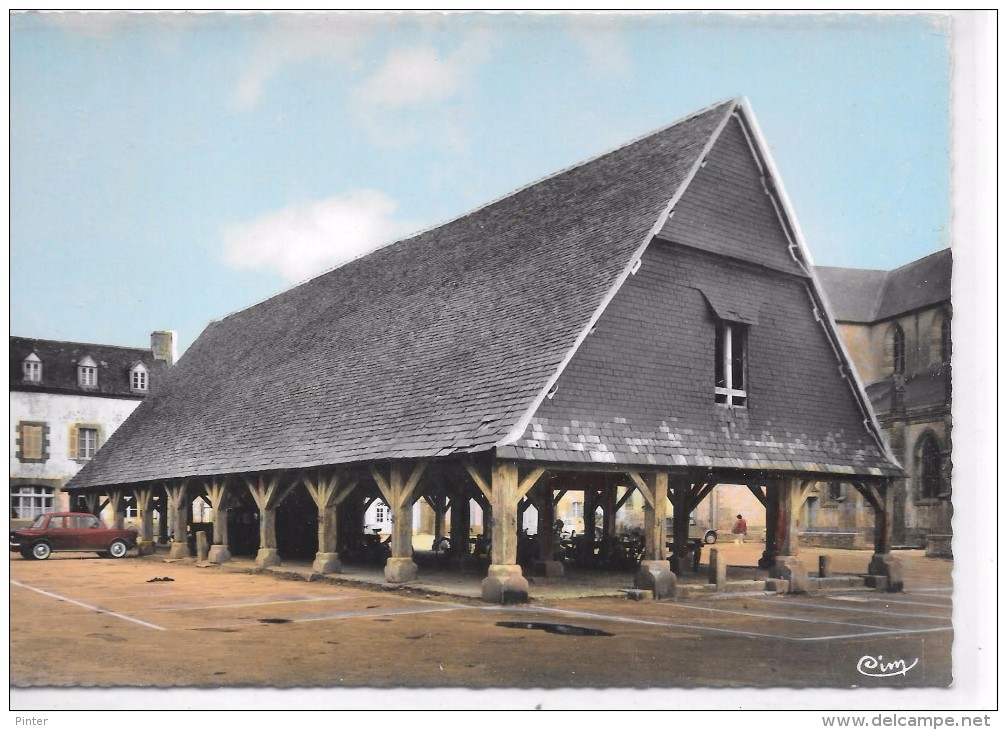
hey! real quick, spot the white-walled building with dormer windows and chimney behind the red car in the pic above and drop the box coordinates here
[10,331,175,526]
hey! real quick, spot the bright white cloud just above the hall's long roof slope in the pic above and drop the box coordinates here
[224,190,419,283]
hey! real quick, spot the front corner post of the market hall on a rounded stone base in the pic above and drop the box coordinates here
[482,460,528,603]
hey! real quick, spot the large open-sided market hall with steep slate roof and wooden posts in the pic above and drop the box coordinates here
[69,100,902,602]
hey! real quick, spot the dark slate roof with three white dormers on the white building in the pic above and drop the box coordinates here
[9,336,168,398]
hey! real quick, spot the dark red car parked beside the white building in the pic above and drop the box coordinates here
[10,513,137,560]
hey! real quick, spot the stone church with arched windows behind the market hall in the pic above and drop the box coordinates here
[818,249,952,557]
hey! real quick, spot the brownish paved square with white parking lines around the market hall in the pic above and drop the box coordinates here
[9,545,953,688]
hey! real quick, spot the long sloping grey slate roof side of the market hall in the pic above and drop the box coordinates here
[68,100,898,488]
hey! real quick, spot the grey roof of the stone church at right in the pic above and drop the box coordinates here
[816,249,952,323]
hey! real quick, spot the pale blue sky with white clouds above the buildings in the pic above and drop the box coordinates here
[9,13,951,350]
